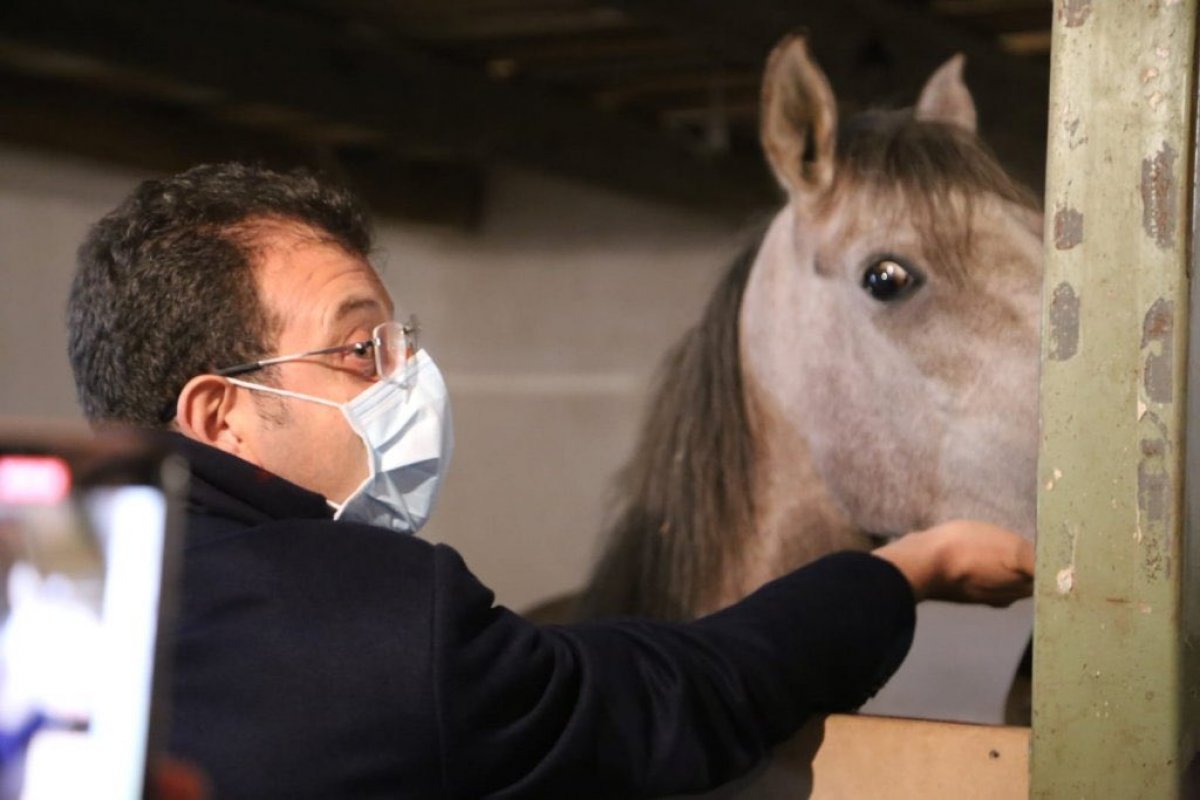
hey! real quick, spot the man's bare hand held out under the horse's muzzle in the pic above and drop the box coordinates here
[874,519,1033,607]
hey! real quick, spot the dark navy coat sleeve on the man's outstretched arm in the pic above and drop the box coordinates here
[432,547,914,798]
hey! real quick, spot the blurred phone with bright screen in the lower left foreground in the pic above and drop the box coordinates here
[0,445,181,800]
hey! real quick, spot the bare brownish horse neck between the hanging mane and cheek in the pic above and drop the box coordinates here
[697,373,870,614]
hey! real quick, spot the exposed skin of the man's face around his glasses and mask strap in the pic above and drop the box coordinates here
[241,222,394,503]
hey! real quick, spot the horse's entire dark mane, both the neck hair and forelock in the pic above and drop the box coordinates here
[576,112,1037,619]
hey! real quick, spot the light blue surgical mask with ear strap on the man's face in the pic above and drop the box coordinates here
[228,350,454,534]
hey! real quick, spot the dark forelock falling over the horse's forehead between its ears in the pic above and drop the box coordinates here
[827,110,1038,283]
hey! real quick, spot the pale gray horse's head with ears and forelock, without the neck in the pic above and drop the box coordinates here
[740,37,1042,542]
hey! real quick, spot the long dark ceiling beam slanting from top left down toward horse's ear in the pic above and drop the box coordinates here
[0,0,775,215]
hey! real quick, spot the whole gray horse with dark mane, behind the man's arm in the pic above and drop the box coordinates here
[578,37,1042,721]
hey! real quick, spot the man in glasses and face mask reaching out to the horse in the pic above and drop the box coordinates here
[70,164,1032,799]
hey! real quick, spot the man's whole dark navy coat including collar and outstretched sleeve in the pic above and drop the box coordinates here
[170,437,914,800]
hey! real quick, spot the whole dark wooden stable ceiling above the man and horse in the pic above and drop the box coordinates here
[0,0,1054,225]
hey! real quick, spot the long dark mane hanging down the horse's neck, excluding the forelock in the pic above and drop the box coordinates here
[578,237,761,619]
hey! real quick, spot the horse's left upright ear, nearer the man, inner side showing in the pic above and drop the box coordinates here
[760,35,838,194]
